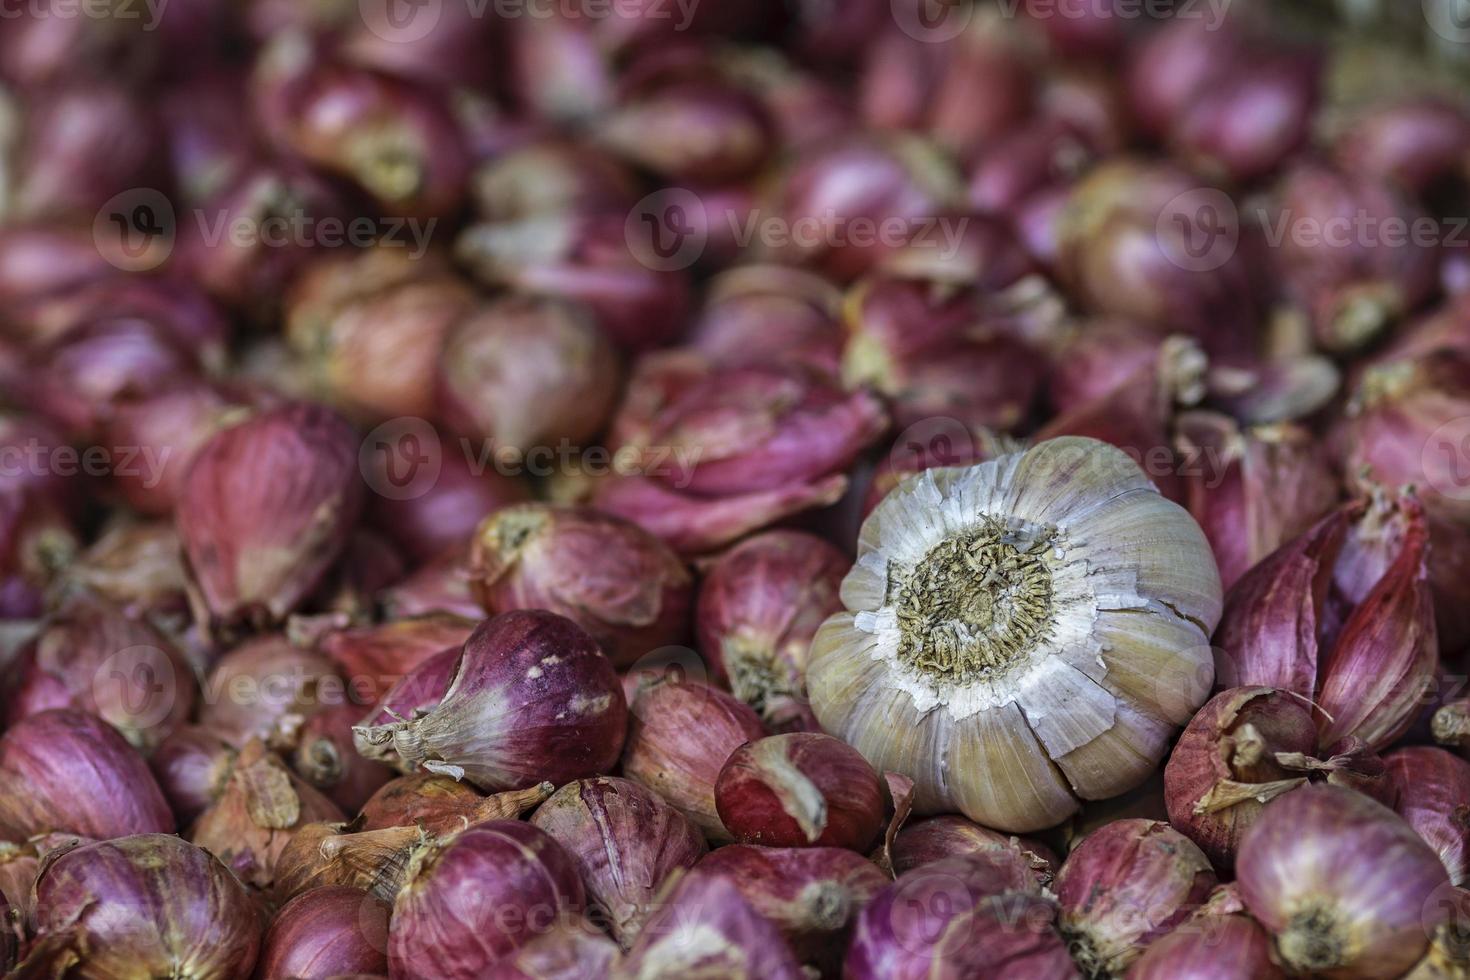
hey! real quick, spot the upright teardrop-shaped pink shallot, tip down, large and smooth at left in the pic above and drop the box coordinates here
[175,404,363,627]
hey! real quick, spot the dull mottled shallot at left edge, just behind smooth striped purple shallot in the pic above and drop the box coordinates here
[6,594,198,754]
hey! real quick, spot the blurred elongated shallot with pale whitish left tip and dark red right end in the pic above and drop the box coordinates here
[456,210,689,351]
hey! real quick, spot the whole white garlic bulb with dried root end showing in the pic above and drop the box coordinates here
[807,438,1220,832]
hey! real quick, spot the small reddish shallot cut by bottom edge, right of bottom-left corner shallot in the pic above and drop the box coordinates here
[257,886,390,980]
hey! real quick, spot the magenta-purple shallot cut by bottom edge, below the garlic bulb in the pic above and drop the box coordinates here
[842,854,1078,980]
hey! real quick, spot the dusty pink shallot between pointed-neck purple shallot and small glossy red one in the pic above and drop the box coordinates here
[622,680,766,843]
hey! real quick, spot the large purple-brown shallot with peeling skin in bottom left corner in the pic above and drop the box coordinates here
[26,833,263,980]
